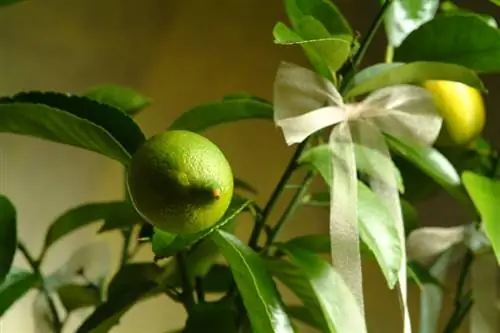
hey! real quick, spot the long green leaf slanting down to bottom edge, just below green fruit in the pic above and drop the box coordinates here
[210,230,292,332]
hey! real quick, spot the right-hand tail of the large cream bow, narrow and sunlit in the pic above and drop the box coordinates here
[353,120,411,333]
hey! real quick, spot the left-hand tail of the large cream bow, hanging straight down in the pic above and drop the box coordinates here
[330,122,367,333]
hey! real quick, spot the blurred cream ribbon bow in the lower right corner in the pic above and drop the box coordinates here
[408,225,500,333]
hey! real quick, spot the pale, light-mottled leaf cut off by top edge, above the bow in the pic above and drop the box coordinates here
[382,0,439,47]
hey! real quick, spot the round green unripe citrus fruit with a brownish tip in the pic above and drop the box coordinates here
[127,130,234,234]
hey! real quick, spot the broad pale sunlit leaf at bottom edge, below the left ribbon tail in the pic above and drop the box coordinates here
[267,246,363,332]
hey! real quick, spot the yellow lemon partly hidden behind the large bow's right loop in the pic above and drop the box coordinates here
[422,80,486,146]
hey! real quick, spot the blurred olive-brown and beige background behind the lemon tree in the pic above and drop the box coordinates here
[0,0,498,333]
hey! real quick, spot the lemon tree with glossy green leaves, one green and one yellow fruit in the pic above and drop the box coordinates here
[0,0,500,333]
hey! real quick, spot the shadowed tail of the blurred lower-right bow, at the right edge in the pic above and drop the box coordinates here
[470,253,500,333]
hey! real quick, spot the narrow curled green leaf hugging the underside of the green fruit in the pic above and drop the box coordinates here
[152,195,250,258]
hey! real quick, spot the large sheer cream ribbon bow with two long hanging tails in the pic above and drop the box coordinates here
[274,63,442,333]
